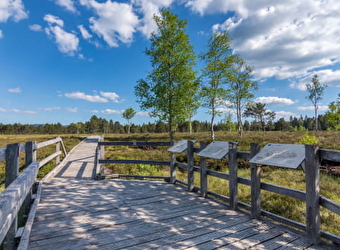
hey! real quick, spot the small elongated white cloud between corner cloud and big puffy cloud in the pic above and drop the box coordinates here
[44,14,79,56]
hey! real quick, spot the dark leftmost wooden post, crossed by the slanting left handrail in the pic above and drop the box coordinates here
[3,143,20,250]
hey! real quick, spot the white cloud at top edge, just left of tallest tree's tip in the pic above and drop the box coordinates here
[132,0,174,37]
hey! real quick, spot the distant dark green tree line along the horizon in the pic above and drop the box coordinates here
[0,114,334,134]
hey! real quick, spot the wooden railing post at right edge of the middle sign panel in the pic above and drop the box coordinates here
[228,142,238,209]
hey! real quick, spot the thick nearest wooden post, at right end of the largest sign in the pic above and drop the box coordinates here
[305,145,320,244]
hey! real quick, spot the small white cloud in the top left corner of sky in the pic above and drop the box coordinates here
[0,0,28,23]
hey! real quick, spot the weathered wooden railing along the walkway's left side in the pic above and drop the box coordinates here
[0,137,67,249]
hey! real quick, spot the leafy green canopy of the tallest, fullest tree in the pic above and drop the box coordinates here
[135,9,199,138]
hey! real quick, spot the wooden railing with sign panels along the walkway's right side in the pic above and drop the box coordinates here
[97,141,340,244]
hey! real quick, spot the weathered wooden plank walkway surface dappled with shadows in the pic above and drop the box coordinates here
[29,138,334,250]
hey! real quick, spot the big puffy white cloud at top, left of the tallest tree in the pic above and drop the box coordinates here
[80,0,139,47]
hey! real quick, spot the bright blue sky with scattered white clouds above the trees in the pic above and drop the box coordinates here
[0,0,340,125]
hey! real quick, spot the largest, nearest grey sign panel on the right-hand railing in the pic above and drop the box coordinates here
[249,143,305,168]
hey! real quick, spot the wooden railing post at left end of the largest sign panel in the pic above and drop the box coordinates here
[250,143,262,219]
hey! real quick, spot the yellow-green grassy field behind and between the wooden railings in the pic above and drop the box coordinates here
[0,131,340,235]
